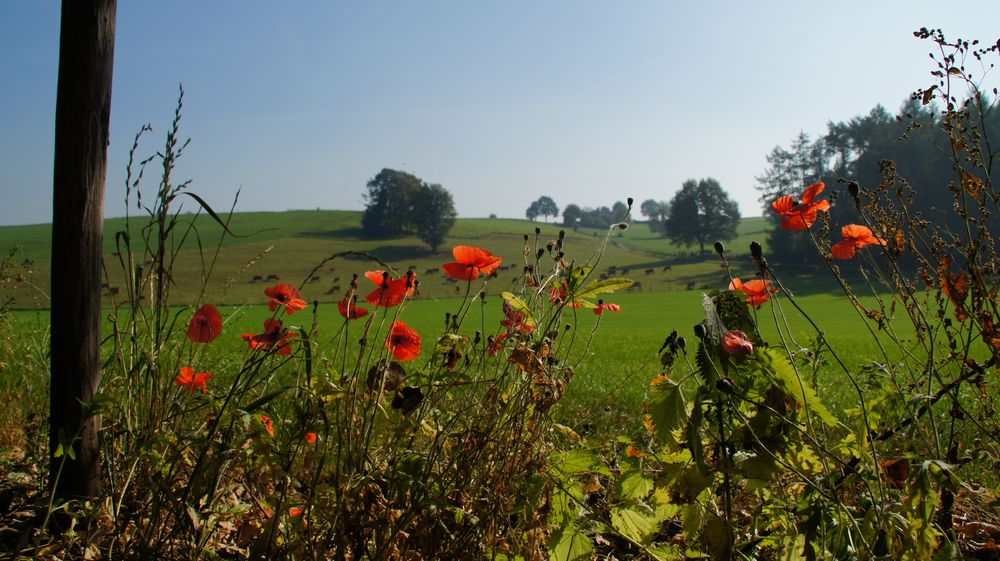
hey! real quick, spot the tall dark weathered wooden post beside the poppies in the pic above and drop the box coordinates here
[49,0,117,498]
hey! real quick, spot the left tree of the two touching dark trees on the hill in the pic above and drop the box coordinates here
[361,168,422,238]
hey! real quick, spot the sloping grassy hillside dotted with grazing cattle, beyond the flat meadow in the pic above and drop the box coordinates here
[0,210,768,308]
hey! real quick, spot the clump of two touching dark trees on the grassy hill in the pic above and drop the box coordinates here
[361,168,457,251]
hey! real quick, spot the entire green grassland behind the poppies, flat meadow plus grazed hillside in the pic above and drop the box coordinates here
[0,211,908,438]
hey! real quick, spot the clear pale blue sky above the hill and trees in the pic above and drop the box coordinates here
[0,0,1000,224]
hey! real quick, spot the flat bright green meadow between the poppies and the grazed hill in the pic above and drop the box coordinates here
[8,286,900,437]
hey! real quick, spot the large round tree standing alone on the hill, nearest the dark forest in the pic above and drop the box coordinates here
[666,178,740,254]
